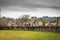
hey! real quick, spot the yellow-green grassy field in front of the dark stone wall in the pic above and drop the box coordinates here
[0,30,60,40]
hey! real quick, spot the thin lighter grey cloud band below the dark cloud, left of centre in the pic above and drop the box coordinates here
[2,7,37,12]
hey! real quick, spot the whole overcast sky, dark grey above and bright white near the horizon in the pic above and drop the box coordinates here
[0,0,60,18]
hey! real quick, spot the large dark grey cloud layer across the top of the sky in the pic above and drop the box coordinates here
[0,0,60,10]
